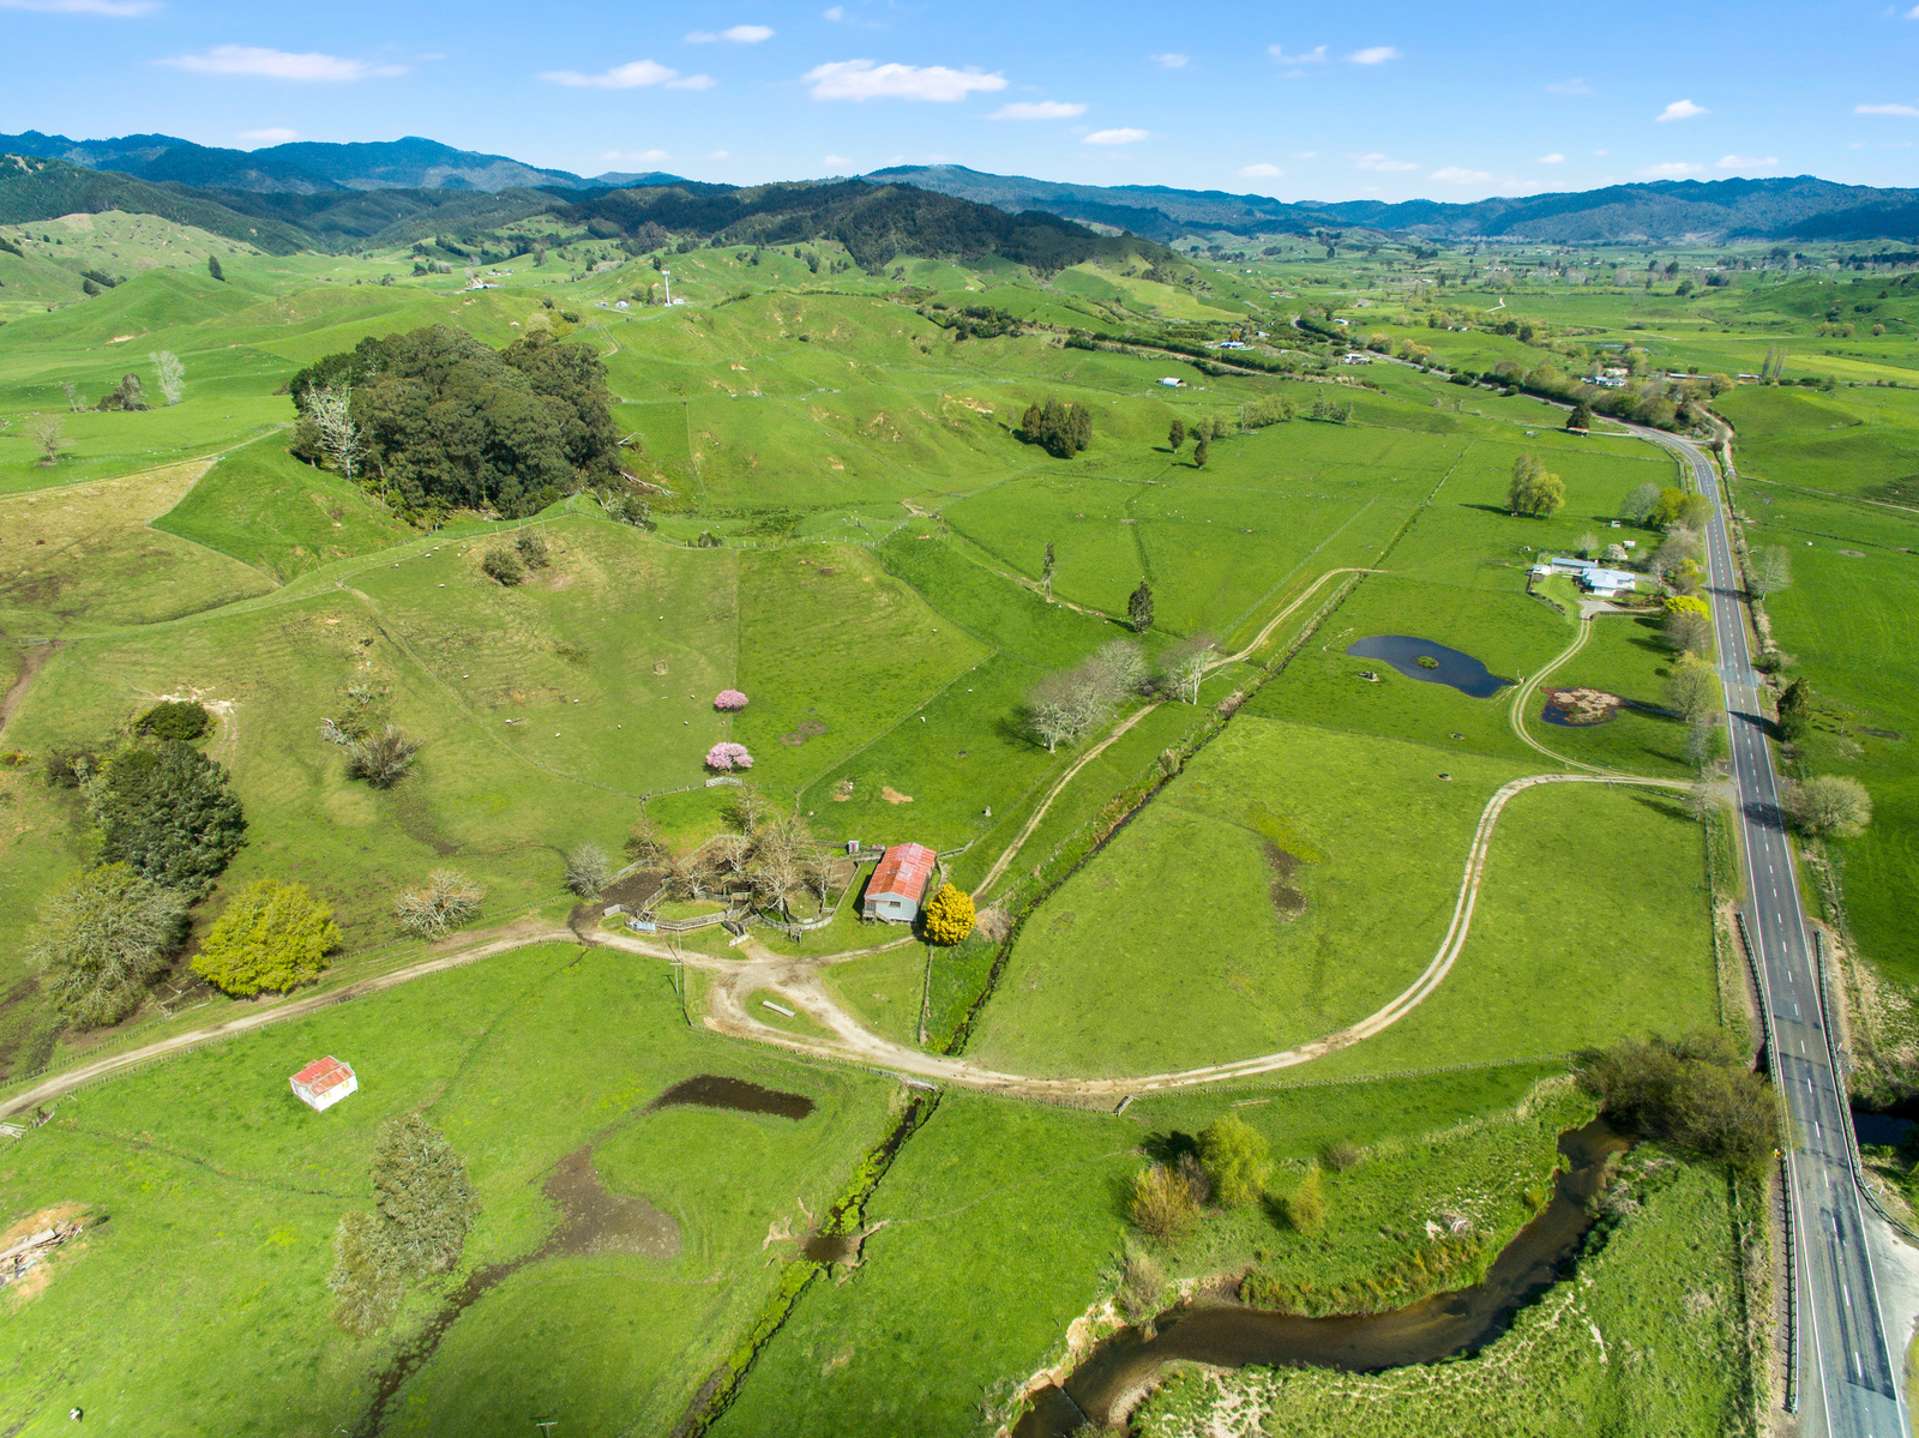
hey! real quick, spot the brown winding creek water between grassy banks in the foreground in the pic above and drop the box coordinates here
[1013,1119,1627,1438]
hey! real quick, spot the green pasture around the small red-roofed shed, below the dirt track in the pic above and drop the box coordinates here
[0,947,892,1436]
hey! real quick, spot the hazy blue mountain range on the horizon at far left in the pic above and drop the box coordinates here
[0,131,677,194]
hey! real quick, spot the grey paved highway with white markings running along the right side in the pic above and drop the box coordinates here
[1639,430,1907,1438]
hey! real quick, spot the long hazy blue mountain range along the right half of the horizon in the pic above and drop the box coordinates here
[865,165,1919,244]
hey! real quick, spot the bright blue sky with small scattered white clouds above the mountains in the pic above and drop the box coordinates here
[0,0,1919,200]
